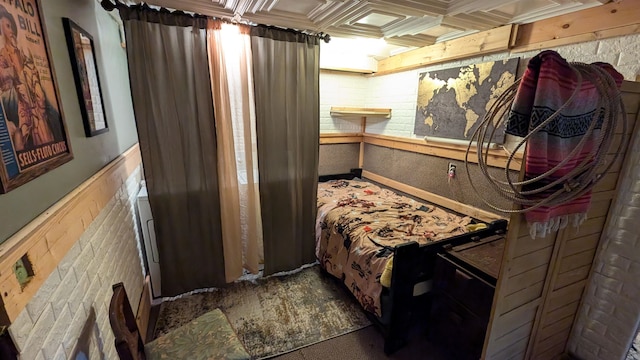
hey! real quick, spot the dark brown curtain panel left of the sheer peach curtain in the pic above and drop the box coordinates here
[118,6,225,296]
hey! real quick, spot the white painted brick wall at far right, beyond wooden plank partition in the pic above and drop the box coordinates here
[568,104,640,360]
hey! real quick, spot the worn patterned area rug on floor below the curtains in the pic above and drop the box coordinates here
[155,265,371,359]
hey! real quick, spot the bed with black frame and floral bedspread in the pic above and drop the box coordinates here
[316,171,507,354]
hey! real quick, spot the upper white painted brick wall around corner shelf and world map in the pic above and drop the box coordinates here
[320,34,640,137]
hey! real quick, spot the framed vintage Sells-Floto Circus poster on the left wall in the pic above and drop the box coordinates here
[0,0,73,193]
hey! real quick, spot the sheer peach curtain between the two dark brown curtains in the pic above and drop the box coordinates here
[207,20,264,282]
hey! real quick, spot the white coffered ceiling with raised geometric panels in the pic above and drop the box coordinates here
[138,0,608,47]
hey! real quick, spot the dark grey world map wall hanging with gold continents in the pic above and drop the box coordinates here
[414,58,519,144]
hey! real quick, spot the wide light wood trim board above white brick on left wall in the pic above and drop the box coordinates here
[0,144,142,325]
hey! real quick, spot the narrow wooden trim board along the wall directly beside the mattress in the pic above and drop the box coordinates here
[362,170,504,222]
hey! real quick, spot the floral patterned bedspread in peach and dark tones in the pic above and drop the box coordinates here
[316,180,471,316]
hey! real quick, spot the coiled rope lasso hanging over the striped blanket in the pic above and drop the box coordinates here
[465,62,627,213]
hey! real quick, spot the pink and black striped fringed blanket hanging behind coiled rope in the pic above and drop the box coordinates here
[506,51,623,238]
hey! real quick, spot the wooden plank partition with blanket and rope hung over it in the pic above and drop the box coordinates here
[483,82,640,360]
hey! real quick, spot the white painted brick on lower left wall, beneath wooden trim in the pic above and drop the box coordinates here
[9,168,144,360]
